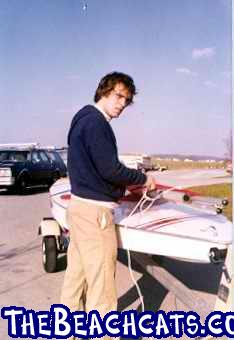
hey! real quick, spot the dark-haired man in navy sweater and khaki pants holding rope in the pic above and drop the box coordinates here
[61,72,155,338]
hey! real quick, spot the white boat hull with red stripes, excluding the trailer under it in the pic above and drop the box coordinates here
[41,179,232,263]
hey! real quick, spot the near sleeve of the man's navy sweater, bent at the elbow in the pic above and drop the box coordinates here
[86,119,146,186]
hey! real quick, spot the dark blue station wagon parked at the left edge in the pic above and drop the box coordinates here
[0,147,67,192]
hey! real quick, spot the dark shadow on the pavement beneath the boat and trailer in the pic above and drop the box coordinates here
[118,250,222,311]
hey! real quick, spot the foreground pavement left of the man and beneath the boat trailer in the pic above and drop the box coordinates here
[0,179,230,340]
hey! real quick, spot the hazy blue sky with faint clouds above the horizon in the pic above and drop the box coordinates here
[0,0,231,157]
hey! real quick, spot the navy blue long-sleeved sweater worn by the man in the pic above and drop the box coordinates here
[68,105,146,202]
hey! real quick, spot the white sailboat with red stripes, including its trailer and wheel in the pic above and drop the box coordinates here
[39,179,232,320]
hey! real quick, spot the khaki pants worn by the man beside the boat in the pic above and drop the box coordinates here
[61,198,117,339]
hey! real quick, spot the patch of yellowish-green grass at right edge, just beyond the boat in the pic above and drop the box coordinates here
[188,183,232,221]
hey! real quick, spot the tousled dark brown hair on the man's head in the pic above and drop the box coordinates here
[94,71,137,105]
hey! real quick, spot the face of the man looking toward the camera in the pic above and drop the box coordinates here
[99,83,131,118]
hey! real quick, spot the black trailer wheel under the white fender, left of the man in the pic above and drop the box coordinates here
[42,236,58,273]
